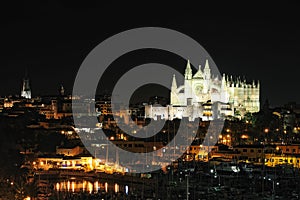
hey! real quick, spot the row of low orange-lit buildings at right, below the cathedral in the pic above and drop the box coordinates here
[185,143,300,169]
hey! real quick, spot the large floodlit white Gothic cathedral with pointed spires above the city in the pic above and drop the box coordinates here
[145,60,260,120]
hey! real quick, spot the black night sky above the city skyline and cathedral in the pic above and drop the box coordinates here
[0,1,300,106]
